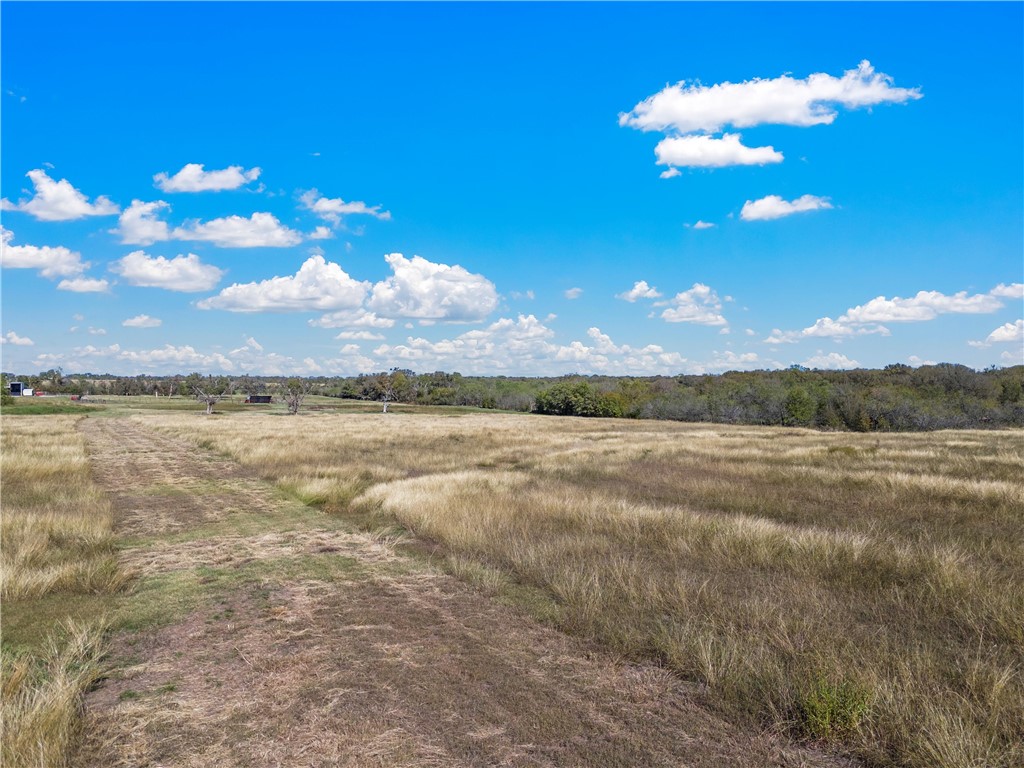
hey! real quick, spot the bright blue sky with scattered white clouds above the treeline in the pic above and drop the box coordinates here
[0,2,1024,375]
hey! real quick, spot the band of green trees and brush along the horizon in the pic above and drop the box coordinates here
[4,364,1024,432]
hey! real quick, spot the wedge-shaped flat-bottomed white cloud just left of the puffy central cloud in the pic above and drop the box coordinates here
[197,254,369,312]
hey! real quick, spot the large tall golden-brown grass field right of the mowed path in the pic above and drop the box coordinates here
[135,411,1024,768]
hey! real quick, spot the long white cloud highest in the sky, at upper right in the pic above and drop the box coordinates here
[618,60,922,133]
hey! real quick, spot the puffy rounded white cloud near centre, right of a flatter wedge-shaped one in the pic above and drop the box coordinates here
[367,253,498,323]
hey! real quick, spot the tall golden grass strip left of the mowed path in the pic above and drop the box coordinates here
[0,416,126,768]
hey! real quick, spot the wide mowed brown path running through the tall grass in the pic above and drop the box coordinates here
[76,418,847,767]
